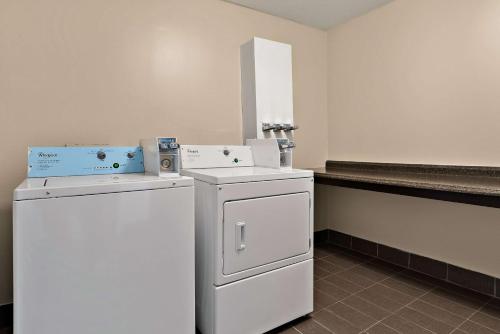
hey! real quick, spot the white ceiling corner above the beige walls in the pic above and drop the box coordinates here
[226,0,392,30]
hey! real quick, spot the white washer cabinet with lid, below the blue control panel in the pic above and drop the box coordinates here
[14,174,195,334]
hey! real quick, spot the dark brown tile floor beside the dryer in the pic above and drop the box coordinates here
[269,245,500,334]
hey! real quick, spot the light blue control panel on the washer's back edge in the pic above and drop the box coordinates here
[28,146,144,177]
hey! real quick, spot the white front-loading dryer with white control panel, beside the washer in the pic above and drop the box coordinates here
[181,145,314,334]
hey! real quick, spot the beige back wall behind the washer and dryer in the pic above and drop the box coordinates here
[0,0,328,304]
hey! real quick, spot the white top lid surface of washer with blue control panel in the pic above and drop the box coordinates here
[14,174,193,201]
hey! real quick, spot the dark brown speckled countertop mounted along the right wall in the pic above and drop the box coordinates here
[313,161,500,207]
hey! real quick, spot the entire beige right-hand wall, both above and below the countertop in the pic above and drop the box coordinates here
[324,0,500,277]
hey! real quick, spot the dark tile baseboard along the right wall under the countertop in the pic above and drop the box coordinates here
[314,229,500,298]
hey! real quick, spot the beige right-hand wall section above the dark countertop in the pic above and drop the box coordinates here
[328,0,500,166]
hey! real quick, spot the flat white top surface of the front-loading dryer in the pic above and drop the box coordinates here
[181,167,313,184]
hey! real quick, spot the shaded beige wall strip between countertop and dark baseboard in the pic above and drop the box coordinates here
[320,185,500,277]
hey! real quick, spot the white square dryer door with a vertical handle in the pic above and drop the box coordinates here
[223,192,311,275]
